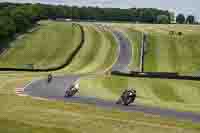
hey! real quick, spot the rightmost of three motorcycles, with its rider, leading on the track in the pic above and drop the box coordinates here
[116,89,136,106]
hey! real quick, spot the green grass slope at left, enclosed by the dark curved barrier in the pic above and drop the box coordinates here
[0,21,81,69]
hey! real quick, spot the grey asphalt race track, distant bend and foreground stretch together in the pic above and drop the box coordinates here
[24,27,200,123]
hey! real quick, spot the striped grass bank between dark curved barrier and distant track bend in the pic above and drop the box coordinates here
[62,25,117,73]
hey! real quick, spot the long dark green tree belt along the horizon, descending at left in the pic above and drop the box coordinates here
[0,3,173,46]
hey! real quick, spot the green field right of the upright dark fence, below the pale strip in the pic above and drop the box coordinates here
[145,33,200,74]
